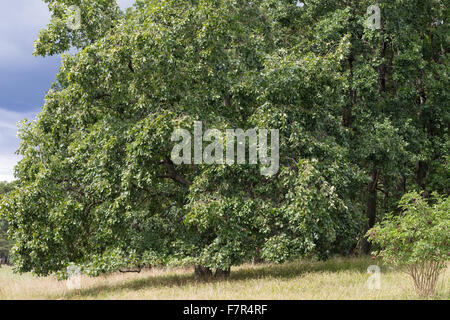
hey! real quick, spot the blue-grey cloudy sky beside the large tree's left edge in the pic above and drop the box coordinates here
[0,0,134,181]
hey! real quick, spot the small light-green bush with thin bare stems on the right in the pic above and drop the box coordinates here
[366,192,450,296]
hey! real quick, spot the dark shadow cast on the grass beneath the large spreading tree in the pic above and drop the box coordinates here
[64,258,390,299]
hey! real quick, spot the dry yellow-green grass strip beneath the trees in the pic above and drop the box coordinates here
[0,258,450,300]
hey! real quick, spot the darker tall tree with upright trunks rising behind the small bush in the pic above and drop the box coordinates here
[282,0,449,253]
